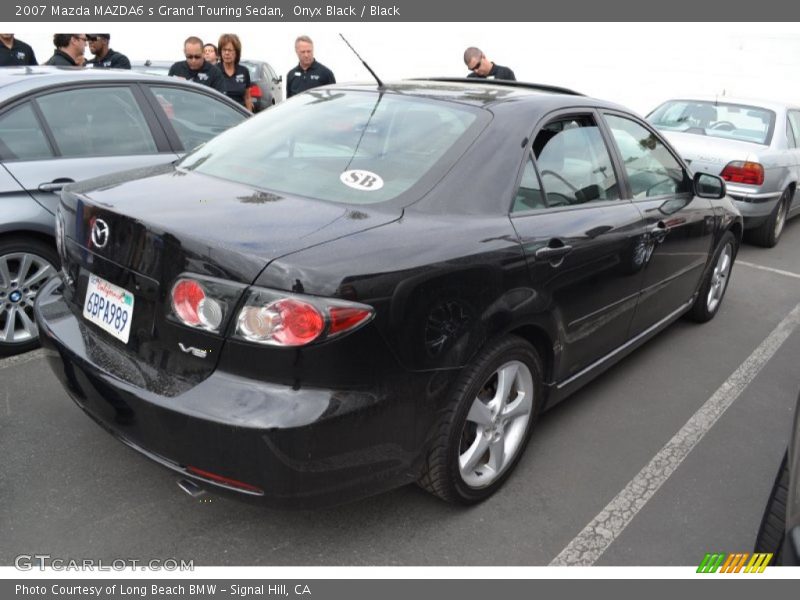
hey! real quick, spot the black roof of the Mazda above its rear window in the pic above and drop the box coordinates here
[325,77,630,112]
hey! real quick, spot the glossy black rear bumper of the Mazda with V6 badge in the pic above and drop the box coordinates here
[35,280,433,507]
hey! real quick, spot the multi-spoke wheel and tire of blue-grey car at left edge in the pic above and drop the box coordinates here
[0,236,59,356]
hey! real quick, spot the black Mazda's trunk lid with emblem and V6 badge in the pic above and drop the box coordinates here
[58,168,400,392]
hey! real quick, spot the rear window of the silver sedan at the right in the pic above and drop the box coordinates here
[647,100,775,145]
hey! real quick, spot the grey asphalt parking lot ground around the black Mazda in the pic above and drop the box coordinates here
[0,219,800,566]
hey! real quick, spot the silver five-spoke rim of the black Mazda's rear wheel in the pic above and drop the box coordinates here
[458,360,533,488]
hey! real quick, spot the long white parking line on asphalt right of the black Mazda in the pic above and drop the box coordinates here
[550,304,800,566]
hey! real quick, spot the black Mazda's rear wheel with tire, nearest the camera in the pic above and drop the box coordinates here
[418,335,543,504]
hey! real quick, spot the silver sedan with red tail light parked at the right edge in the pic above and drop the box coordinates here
[647,97,800,247]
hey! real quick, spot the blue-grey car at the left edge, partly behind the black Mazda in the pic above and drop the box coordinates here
[0,67,249,356]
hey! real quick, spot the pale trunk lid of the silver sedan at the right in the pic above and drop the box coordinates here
[661,131,766,175]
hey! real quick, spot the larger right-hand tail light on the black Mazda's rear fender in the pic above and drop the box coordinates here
[235,289,374,347]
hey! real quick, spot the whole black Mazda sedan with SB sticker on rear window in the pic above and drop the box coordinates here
[35,80,742,506]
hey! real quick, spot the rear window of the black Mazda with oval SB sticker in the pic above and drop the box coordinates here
[180,90,488,204]
